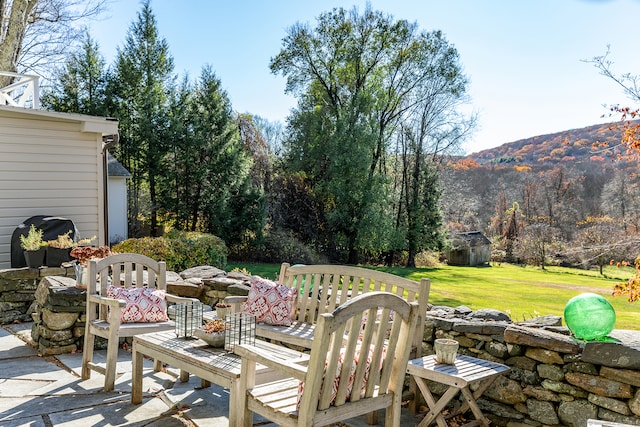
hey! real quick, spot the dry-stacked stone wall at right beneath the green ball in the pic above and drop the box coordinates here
[423,307,640,427]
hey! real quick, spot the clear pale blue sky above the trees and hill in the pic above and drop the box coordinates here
[90,0,640,153]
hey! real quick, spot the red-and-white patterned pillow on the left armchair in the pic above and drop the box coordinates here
[107,286,169,323]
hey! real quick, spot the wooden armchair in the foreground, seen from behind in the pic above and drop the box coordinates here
[231,291,419,427]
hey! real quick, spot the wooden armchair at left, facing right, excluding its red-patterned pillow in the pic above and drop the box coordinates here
[82,253,198,391]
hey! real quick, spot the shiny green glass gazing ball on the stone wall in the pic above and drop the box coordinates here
[564,293,616,340]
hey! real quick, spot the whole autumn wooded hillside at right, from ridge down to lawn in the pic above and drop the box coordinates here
[440,118,640,266]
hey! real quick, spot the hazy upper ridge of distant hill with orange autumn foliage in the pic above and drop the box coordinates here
[466,122,622,165]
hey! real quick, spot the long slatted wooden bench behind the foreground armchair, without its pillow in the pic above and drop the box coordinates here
[225,263,430,409]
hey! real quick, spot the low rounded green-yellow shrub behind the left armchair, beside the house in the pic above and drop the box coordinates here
[113,231,227,271]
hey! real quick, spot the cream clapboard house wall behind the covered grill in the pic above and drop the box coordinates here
[0,106,118,269]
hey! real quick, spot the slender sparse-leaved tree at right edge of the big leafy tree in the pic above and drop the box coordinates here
[396,48,475,267]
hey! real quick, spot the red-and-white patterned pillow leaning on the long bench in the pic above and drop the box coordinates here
[242,276,295,326]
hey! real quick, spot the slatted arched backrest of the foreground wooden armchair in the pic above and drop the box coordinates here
[299,291,418,421]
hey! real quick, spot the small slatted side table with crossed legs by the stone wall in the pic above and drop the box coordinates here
[407,355,510,427]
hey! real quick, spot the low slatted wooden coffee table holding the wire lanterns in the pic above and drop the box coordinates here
[131,331,309,426]
